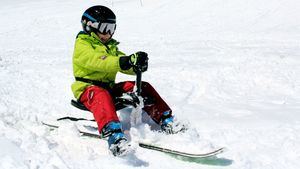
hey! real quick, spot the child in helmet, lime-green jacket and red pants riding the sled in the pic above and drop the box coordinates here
[72,6,185,156]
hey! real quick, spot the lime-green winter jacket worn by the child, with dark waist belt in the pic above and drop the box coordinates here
[71,32,134,99]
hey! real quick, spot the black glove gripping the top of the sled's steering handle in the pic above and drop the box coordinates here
[119,52,149,72]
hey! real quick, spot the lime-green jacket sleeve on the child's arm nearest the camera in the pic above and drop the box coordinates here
[73,38,121,72]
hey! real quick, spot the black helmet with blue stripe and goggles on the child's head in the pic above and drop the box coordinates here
[81,5,116,35]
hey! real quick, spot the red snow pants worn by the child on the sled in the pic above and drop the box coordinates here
[80,81,172,133]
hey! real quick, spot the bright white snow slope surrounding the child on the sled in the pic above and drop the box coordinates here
[0,0,300,169]
